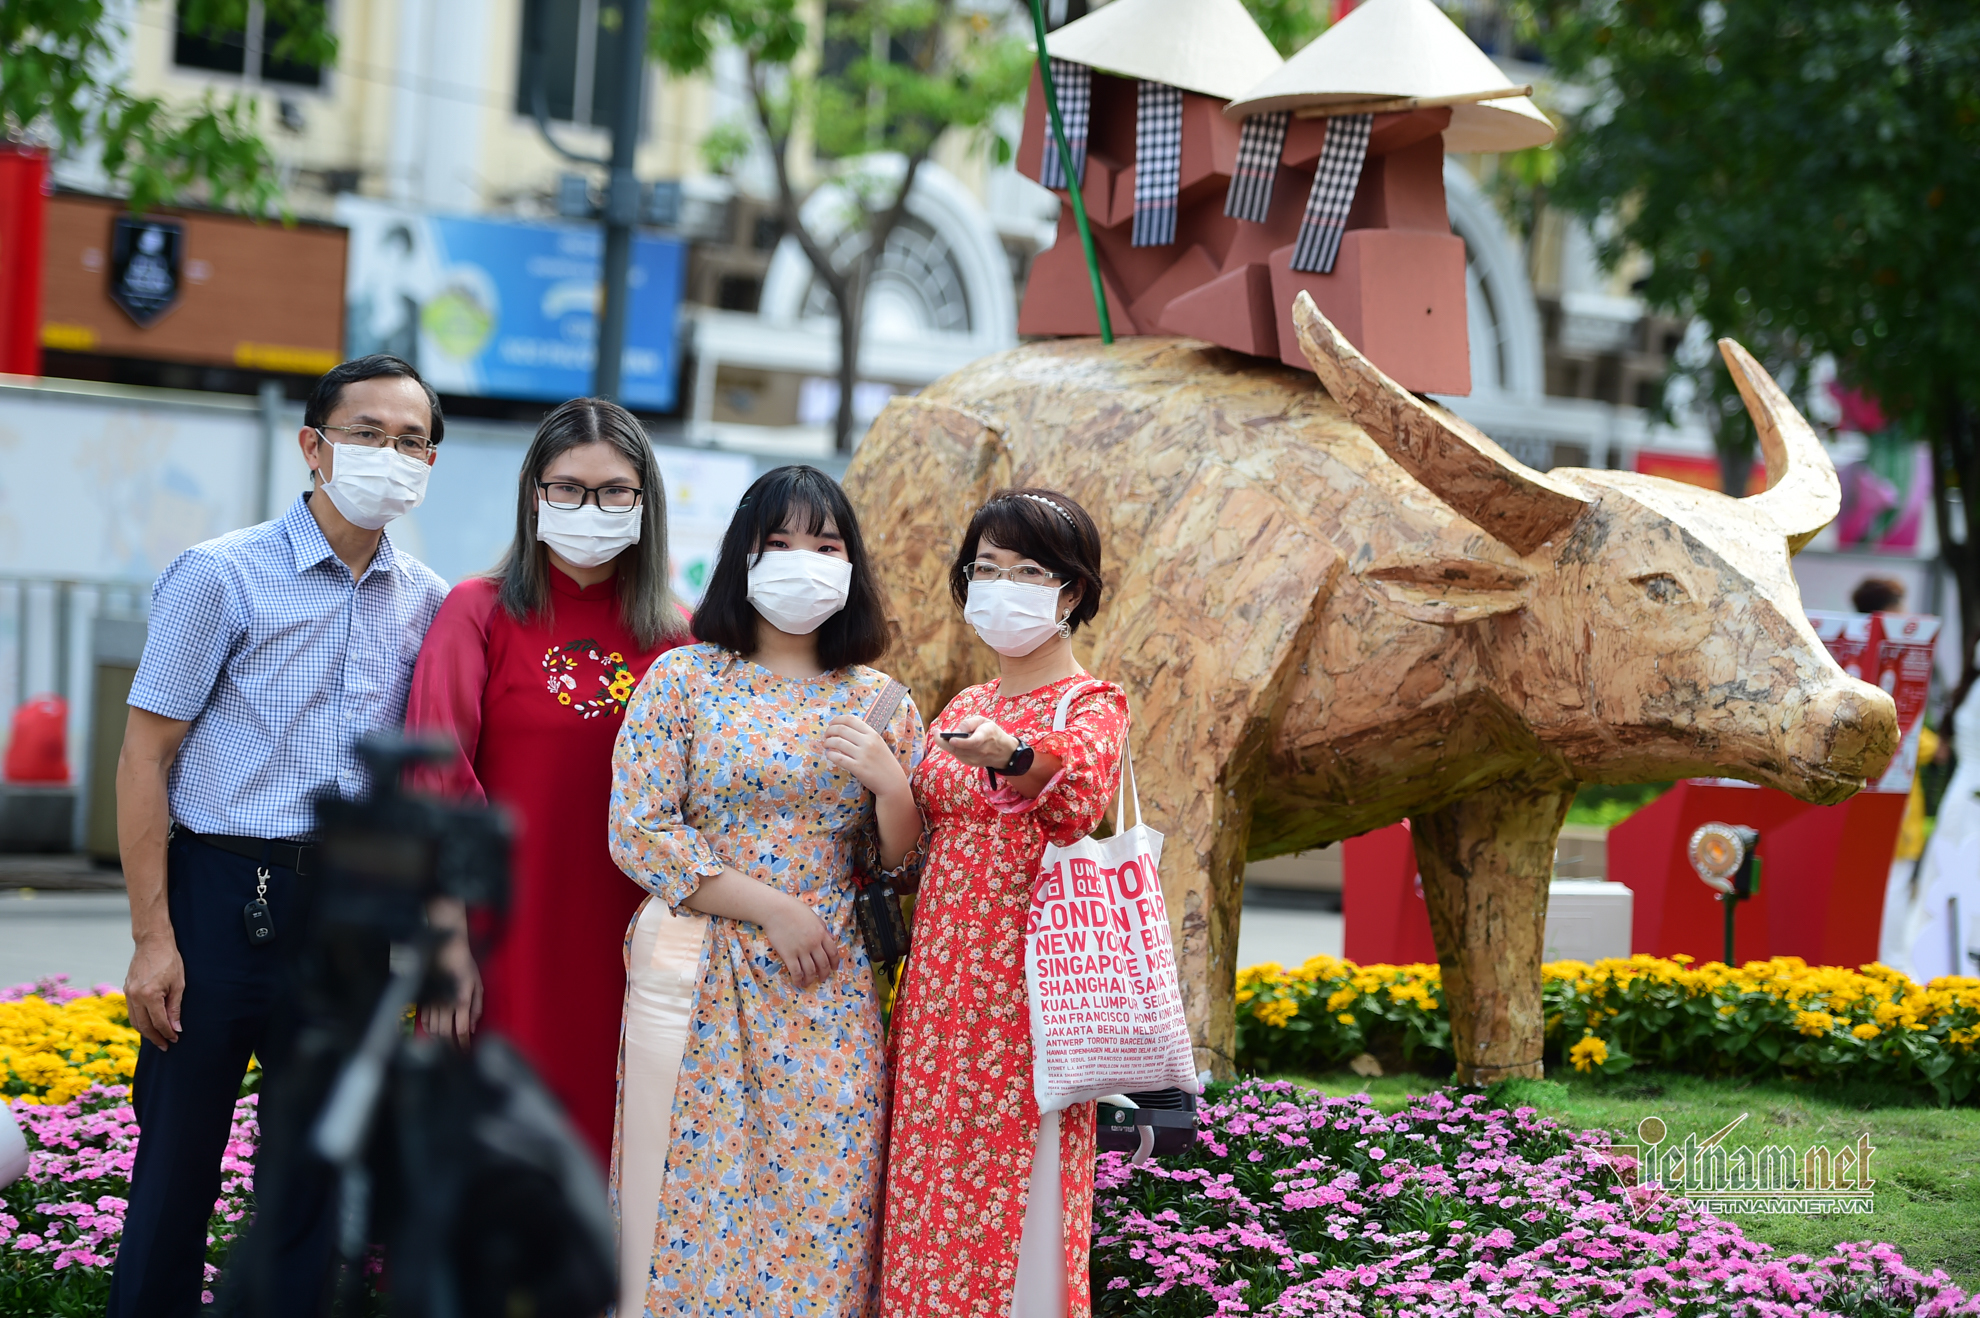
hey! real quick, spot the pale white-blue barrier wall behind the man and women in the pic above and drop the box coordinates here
[0,378,764,823]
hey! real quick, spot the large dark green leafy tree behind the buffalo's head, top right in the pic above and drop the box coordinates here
[1533,0,1980,696]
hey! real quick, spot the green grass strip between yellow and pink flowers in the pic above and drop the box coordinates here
[1281,1071,1980,1292]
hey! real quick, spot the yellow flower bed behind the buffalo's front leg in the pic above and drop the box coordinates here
[1238,956,1980,1102]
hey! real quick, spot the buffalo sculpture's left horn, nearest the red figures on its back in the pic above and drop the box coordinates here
[1293,293,1591,556]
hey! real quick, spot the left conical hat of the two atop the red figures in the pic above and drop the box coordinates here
[1045,0,1283,101]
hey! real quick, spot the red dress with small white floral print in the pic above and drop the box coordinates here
[881,675,1129,1318]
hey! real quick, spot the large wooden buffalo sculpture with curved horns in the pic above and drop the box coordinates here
[845,295,1897,1083]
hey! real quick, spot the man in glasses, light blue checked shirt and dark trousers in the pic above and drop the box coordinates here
[109,354,447,1318]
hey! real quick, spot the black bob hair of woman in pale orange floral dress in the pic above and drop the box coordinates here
[693,465,891,669]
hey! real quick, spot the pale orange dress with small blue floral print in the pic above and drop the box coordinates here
[612,645,923,1318]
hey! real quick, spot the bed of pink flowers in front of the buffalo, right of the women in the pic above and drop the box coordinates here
[1093,1081,1980,1318]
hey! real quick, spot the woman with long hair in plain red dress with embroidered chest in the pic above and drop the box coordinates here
[406,398,687,1162]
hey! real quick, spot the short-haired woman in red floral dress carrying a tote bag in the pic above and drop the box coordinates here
[881,489,1129,1318]
